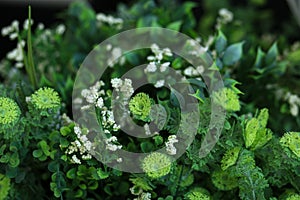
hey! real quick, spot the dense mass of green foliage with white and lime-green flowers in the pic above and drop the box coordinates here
[0,0,300,200]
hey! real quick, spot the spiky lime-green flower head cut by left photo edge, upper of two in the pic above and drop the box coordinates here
[0,97,21,127]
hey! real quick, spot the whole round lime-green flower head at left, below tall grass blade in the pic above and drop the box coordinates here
[31,87,61,110]
